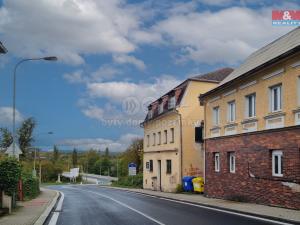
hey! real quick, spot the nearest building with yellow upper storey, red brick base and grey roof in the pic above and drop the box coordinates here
[200,27,300,209]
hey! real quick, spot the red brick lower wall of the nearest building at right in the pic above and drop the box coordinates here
[205,126,300,209]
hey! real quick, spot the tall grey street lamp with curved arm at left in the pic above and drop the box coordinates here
[13,56,57,156]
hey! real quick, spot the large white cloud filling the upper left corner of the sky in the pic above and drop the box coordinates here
[0,0,153,64]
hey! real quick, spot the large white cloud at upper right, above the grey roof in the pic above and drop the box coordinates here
[153,7,293,64]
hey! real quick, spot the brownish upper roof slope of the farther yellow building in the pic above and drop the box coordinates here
[190,67,233,83]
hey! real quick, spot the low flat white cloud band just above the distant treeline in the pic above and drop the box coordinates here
[57,133,141,152]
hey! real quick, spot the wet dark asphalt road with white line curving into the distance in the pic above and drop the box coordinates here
[47,185,296,225]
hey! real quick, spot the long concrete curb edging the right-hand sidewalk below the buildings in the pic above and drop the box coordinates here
[99,185,300,225]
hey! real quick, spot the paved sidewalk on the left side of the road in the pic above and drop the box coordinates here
[0,188,58,225]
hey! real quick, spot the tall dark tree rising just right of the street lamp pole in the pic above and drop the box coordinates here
[18,117,36,157]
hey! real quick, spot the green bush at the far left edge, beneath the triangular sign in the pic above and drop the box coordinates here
[0,157,21,196]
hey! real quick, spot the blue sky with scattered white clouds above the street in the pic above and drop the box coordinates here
[0,0,300,151]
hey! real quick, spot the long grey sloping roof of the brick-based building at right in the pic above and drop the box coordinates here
[201,27,300,97]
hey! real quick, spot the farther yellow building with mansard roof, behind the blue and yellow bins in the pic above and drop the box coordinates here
[142,68,232,192]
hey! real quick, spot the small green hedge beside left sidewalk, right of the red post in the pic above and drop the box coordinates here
[22,174,40,200]
